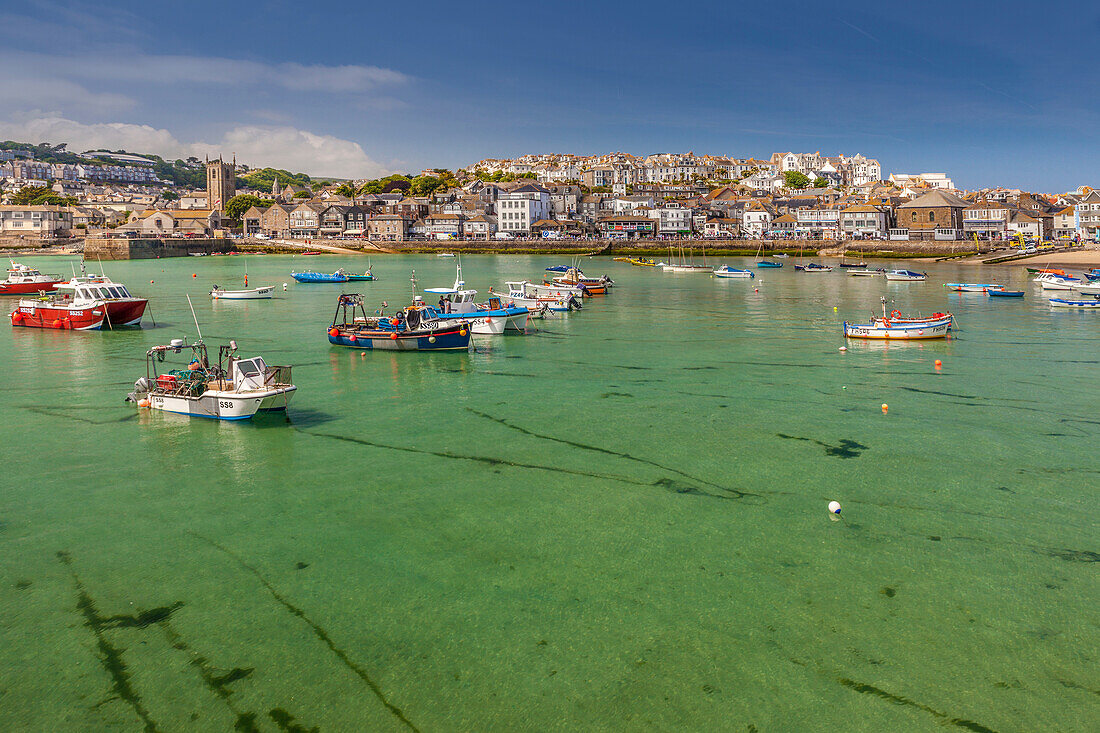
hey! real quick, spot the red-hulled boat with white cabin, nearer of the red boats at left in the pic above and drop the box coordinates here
[11,270,149,331]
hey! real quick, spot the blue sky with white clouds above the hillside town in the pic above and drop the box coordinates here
[0,0,1100,190]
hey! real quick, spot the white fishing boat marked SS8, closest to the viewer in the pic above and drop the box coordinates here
[127,339,297,420]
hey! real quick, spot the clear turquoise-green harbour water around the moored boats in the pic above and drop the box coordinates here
[0,256,1100,731]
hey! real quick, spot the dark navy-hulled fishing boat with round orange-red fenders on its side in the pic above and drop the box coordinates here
[328,293,471,351]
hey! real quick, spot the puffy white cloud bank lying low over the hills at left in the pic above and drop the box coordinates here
[0,117,391,178]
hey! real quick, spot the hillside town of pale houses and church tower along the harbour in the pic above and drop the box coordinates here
[0,144,1100,243]
